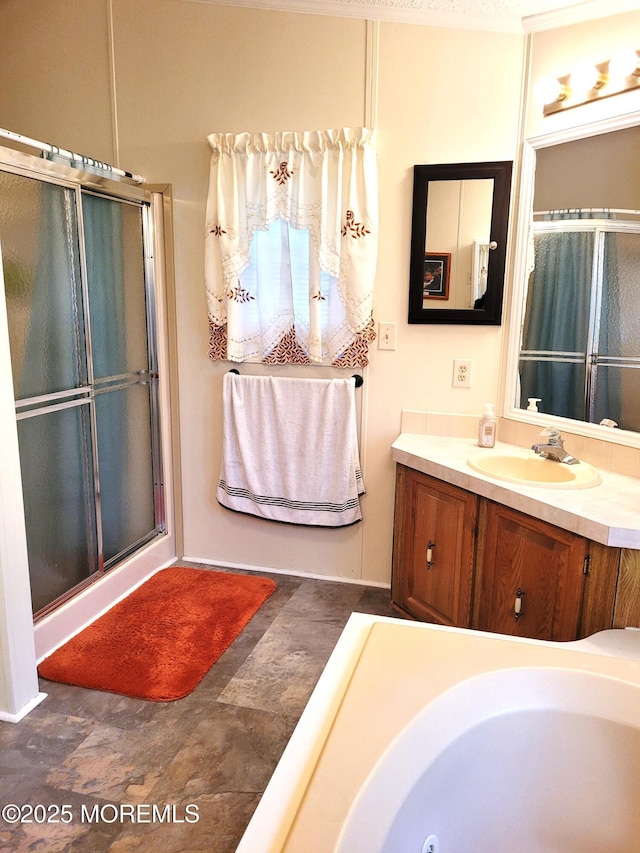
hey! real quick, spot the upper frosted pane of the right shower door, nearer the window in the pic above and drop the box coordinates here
[82,194,148,379]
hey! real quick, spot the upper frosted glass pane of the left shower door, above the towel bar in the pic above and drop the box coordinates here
[0,172,86,399]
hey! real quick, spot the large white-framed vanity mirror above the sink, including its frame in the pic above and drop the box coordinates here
[510,121,640,432]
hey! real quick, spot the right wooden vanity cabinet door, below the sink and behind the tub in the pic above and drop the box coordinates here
[473,501,588,641]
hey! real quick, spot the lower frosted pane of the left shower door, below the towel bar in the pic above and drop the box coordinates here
[18,405,98,613]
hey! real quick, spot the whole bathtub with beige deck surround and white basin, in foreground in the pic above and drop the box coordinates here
[238,616,640,853]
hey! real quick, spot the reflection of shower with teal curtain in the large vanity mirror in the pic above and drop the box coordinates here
[519,209,640,431]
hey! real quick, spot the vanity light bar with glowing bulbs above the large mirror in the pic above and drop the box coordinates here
[536,48,640,115]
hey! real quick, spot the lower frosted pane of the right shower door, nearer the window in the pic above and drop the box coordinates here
[95,384,155,561]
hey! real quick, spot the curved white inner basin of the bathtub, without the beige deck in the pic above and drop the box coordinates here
[337,669,640,853]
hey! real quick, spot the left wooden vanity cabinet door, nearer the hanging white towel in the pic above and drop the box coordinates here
[392,466,478,628]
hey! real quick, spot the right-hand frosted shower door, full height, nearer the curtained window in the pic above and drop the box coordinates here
[82,193,159,567]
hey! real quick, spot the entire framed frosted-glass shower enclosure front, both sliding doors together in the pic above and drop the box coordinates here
[0,149,166,618]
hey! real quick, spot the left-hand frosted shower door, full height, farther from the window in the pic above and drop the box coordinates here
[0,172,99,612]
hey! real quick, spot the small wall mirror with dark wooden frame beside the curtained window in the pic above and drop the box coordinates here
[409,160,513,326]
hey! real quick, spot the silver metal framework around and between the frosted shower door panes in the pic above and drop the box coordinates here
[0,149,167,621]
